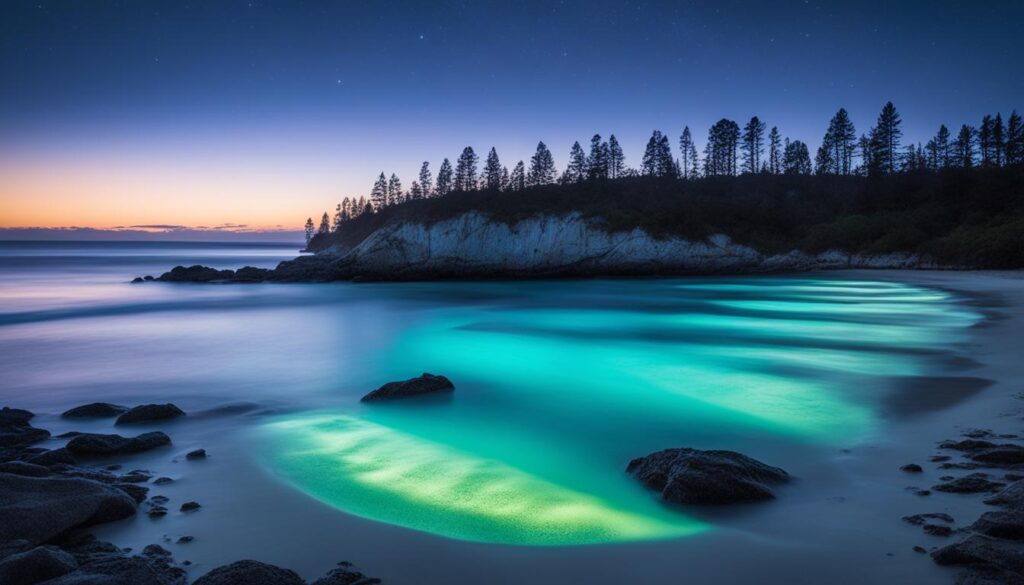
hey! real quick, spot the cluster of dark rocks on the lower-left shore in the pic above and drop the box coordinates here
[0,403,380,585]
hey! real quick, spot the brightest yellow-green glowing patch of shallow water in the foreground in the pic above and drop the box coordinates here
[267,415,706,545]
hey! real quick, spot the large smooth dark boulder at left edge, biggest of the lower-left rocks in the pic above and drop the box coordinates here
[0,473,135,544]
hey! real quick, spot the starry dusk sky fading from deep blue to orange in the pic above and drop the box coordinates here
[0,0,1024,233]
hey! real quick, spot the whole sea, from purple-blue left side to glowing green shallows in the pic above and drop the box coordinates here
[0,244,980,545]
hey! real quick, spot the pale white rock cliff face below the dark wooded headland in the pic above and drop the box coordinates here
[322,213,926,277]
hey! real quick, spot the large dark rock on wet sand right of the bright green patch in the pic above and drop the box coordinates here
[626,449,790,505]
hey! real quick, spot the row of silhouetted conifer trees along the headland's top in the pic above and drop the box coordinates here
[305,101,1024,243]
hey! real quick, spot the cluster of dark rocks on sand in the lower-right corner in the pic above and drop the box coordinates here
[903,430,1024,585]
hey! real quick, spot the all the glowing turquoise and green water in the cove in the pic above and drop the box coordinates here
[265,278,980,545]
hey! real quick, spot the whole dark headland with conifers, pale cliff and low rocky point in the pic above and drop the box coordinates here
[148,102,1024,282]
